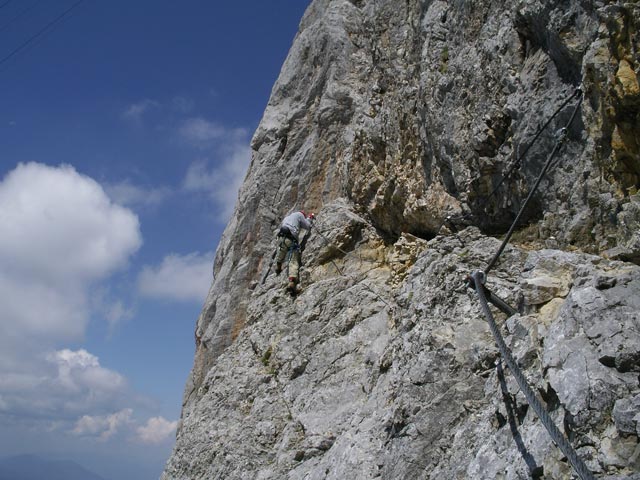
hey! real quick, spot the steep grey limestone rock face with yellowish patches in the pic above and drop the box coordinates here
[163,0,640,480]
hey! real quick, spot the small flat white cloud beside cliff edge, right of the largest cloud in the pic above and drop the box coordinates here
[138,252,213,302]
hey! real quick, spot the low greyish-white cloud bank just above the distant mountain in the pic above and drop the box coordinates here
[0,349,178,444]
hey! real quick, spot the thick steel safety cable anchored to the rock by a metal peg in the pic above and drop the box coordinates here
[468,88,595,480]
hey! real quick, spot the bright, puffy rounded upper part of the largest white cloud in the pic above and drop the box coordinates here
[0,163,141,281]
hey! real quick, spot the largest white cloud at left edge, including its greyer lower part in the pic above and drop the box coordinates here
[0,163,142,342]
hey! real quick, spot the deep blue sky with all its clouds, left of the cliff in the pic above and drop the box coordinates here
[0,0,309,480]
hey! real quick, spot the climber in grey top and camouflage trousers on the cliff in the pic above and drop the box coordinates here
[276,210,315,293]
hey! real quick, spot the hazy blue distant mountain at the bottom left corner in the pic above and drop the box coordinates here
[0,455,105,480]
